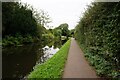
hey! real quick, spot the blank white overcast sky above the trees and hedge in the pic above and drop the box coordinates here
[21,0,93,29]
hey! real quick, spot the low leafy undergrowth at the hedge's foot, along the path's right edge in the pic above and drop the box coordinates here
[81,45,119,77]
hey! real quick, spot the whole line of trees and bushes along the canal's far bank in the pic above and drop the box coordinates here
[2,2,74,47]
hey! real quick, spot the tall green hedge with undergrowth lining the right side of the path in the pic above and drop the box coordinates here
[75,2,120,77]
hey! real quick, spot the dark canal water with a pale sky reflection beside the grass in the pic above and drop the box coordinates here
[2,41,65,78]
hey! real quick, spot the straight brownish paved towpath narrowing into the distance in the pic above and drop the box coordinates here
[63,38,98,78]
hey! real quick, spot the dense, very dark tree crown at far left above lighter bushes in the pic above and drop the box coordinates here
[2,2,37,37]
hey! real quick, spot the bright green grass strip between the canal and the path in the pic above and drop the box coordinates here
[28,40,71,79]
